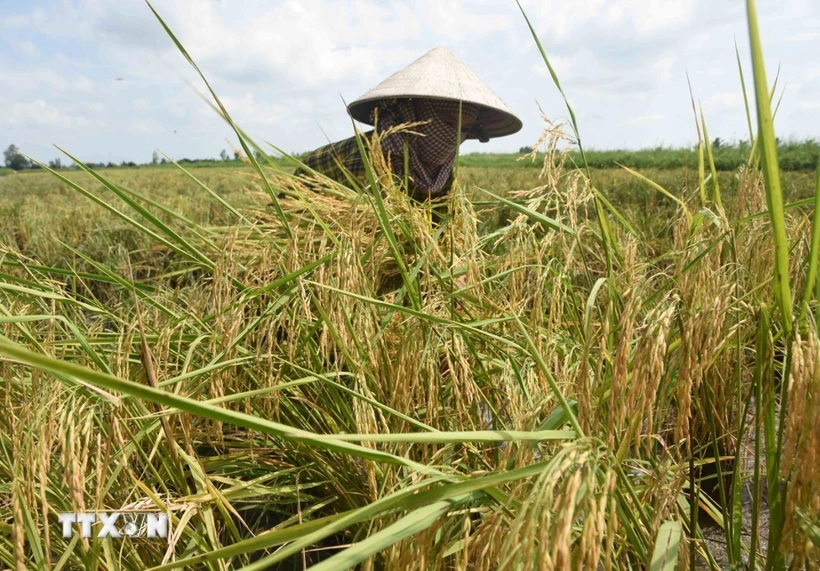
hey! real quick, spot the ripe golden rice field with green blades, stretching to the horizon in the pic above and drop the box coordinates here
[0,2,820,571]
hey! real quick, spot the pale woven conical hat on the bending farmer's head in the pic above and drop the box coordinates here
[347,48,522,138]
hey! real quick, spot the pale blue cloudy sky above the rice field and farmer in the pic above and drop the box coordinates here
[0,0,820,163]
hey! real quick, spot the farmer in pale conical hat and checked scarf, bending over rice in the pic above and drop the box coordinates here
[296,48,521,200]
